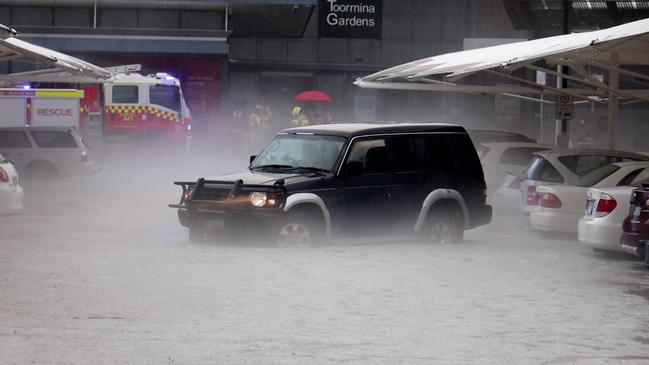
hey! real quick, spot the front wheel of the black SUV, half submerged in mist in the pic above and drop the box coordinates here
[277,211,324,248]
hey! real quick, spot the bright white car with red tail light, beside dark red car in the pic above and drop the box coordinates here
[577,168,649,252]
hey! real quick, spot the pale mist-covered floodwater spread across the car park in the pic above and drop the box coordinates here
[0,142,649,364]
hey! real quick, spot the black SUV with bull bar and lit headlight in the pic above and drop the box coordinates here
[169,123,491,247]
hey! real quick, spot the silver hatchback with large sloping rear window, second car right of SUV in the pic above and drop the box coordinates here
[517,149,649,216]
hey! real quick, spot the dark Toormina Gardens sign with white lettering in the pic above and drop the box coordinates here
[319,0,383,39]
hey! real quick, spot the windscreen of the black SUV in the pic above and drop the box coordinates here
[250,134,345,171]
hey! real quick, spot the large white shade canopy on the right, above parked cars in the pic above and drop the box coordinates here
[355,19,649,102]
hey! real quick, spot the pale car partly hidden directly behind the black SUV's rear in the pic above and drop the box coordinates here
[478,142,552,203]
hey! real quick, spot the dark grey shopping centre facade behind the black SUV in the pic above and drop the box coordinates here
[0,0,649,148]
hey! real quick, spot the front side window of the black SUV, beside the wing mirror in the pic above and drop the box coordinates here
[345,138,389,176]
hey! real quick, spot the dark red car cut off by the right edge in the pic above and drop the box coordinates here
[620,183,649,265]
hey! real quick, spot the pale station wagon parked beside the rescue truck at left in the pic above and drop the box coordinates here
[0,127,99,180]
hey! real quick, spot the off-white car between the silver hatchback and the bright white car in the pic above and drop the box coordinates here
[530,161,649,234]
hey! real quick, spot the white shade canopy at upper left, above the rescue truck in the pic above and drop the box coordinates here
[0,24,116,82]
